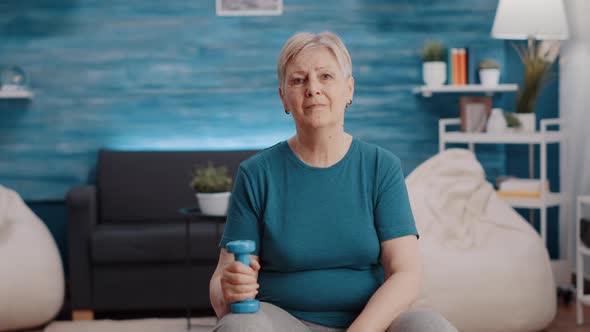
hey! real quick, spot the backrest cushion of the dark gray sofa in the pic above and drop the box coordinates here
[97,150,257,222]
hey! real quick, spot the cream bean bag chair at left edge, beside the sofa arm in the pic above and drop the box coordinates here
[0,185,64,331]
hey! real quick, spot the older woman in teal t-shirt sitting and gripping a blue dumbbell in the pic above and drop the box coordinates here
[210,32,456,332]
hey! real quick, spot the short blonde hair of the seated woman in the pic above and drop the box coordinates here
[277,31,352,88]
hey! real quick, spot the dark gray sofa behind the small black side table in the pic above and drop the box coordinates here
[66,150,257,312]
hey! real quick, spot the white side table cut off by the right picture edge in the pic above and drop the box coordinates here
[576,196,590,325]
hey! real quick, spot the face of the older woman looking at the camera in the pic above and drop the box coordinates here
[279,47,354,129]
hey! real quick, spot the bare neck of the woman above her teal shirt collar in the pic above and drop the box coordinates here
[287,130,352,167]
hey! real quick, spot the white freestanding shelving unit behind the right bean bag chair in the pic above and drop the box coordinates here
[439,119,566,243]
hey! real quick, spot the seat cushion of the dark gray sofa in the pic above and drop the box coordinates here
[90,221,223,264]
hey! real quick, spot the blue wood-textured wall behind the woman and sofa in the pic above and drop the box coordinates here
[0,0,556,260]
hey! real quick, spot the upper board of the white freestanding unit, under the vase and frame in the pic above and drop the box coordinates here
[441,131,563,144]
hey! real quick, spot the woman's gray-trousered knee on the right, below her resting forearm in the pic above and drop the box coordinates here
[387,309,457,332]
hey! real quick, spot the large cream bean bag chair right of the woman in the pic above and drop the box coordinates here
[406,149,557,332]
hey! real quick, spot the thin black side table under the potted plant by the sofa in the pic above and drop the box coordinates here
[178,206,226,330]
